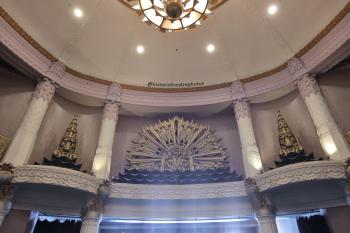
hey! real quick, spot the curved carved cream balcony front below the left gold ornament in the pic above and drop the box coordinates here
[12,165,101,194]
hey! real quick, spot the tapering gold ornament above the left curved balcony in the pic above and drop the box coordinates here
[53,118,78,160]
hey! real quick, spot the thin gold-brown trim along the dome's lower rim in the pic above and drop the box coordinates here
[0,1,350,93]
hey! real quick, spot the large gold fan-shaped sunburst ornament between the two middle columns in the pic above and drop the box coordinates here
[127,117,227,172]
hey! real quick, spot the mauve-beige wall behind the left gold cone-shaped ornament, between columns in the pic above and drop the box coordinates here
[29,95,102,172]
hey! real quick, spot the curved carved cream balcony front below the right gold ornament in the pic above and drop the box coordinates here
[254,161,347,191]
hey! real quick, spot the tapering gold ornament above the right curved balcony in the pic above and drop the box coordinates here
[277,111,303,155]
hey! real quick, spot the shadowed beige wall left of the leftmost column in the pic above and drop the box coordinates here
[0,67,35,138]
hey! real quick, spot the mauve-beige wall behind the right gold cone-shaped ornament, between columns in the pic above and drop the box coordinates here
[251,91,324,170]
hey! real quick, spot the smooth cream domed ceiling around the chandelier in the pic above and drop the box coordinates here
[0,0,348,86]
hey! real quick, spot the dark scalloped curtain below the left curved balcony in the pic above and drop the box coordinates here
[34,220,81,233]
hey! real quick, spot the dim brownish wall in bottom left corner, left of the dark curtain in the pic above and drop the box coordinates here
[0,209,30,233]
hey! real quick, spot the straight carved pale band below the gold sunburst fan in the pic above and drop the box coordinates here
[109,181,247,200]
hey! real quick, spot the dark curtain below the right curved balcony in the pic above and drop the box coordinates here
[297,215,331,233]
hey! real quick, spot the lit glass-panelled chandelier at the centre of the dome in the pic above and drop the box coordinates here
[119,0,227,32]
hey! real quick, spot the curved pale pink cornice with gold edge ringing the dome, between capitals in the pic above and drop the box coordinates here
[0,4,350,107]
